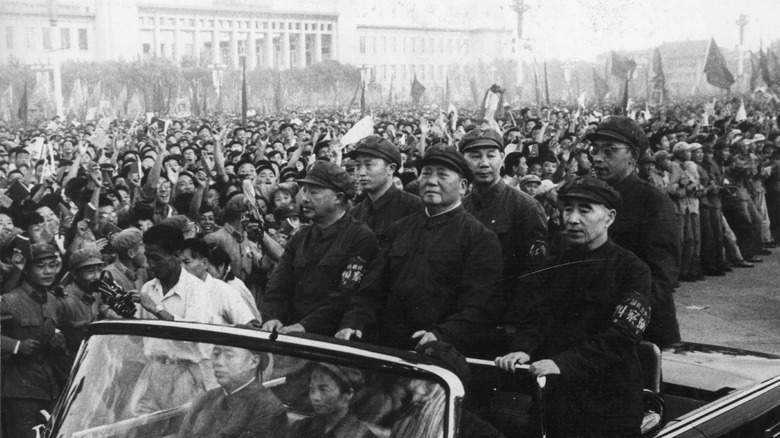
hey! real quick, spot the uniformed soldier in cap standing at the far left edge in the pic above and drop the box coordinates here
[0,243,65,437]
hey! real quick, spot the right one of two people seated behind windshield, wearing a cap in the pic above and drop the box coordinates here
[290,363,376,438]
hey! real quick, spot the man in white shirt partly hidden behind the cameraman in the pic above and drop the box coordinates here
[181,239,260,327]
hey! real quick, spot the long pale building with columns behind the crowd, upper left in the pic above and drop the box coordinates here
[0,0,517,83]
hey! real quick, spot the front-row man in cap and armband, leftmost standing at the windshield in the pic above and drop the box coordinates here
[259,161,379,336]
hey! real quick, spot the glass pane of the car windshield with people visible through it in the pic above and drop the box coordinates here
[49,335,447,438]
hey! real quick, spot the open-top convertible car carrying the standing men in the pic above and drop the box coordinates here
[39,321,780,438]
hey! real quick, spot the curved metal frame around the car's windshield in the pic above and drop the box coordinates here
[45,320,465,437]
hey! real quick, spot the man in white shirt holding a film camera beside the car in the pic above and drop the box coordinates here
[130,225,216,416]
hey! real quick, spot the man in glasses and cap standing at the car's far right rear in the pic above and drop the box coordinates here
[585,116,681,348]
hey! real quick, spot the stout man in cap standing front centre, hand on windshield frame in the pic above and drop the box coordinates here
[337,146,503,355]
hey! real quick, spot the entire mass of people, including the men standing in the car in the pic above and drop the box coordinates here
[0,91,780,436]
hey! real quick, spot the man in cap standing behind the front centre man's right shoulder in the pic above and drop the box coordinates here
[460,129,547,322]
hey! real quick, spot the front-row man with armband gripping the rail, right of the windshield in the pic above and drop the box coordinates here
[496,178,652,438]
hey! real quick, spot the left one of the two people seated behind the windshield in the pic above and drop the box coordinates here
[179,345,288,438]
